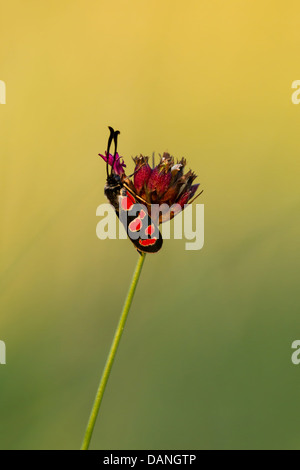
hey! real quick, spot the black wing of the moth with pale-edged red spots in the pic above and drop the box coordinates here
[117,187,163,253]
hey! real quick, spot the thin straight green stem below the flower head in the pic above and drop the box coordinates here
[81,253,145,450]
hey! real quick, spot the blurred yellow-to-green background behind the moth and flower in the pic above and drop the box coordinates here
[0,0,300,450]
